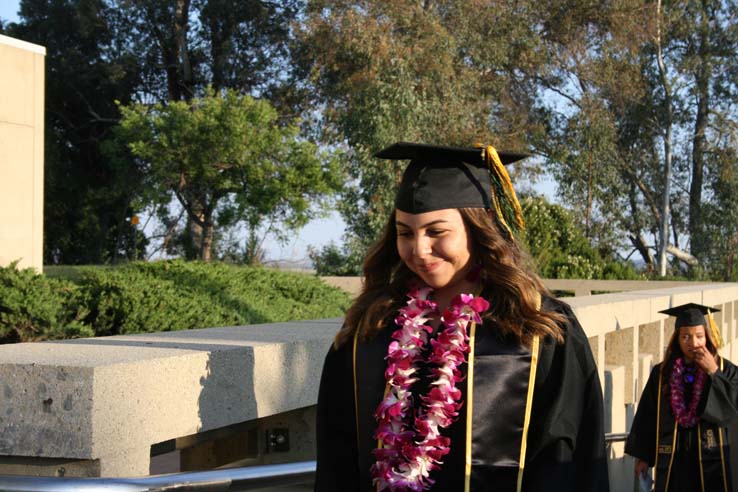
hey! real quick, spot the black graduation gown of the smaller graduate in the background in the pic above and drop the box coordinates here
[625,358,738,492]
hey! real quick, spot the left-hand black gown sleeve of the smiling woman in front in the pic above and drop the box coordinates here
[315,342,359,492]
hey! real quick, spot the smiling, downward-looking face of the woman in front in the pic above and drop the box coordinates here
[395,209,472,289]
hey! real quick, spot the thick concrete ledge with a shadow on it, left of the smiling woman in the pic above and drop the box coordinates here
[0,319,341,466]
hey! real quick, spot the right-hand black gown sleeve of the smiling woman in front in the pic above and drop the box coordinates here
[523,300,609,492]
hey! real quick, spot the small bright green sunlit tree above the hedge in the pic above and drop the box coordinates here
[116,90,341,261]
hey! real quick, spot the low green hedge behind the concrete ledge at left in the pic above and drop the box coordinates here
[0,261,349,343]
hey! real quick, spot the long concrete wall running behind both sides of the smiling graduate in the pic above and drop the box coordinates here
[0,284,738,492]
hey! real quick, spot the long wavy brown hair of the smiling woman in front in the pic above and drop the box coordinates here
[334,208,565,347]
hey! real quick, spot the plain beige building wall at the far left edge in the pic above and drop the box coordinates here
[0,35,46,272]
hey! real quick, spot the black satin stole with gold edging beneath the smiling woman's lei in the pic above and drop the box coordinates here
[354,322,531,491]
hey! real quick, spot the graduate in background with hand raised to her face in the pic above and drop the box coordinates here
[625,303,738,492]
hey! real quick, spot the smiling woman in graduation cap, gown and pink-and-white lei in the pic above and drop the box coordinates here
[315,143,608,492]
